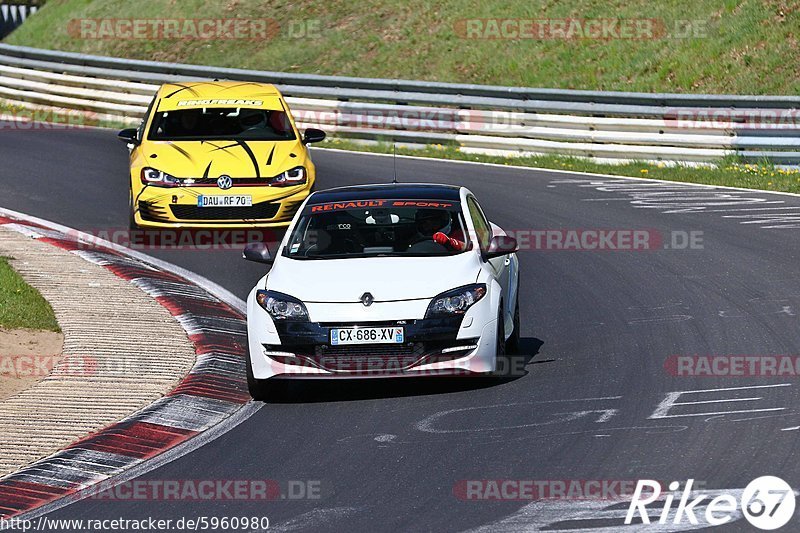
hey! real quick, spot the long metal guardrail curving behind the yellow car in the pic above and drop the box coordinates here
[0,44,800,164]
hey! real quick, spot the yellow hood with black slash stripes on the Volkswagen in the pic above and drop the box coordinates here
[142,140,305,179]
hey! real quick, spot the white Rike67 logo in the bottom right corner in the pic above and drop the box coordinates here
[625,476,795,530]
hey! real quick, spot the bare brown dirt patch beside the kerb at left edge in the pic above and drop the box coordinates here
[0,328,64,400]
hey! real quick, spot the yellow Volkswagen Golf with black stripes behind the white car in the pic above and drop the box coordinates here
[119,81,325,228]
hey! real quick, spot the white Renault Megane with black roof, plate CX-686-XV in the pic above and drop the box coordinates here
[244,184,520,399]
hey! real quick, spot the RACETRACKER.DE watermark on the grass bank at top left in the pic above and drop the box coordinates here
[67,18,322,41]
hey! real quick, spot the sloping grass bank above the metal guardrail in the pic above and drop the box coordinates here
[6,0,800,95]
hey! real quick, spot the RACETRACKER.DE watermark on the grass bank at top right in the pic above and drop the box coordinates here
[453,17,708,41]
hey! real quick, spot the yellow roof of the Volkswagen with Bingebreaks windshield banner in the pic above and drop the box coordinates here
[158,81,283,111]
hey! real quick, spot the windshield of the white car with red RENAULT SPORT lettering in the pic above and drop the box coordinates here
[283,200,471,259]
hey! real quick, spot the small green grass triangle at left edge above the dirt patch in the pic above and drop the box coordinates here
[0,257,61,331]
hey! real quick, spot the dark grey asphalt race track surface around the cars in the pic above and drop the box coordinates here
[0,130,800,531]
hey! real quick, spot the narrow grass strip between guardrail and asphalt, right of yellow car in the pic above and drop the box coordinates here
[316,139,800,193]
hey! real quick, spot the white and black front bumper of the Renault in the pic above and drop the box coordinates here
[247,282,499,380]
